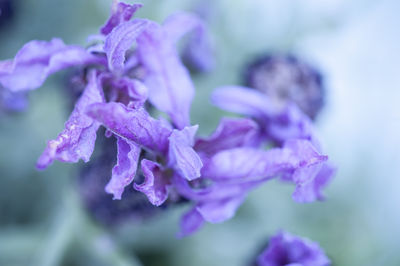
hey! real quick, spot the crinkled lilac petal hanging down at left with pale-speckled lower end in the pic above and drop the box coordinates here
[37,68,104,169]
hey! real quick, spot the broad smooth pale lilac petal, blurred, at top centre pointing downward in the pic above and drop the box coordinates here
[137,23,194,129]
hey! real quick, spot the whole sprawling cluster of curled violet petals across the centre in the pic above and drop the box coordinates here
[0,2,334,235]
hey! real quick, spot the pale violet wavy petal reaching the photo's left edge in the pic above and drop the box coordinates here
[0,39,104,91]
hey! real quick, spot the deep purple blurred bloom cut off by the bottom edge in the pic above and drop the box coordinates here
[257,232,331,266]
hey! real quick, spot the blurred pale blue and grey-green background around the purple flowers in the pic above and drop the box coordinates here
[0,0,400,266]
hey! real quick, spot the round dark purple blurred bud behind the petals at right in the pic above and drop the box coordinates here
[244,54,325,119]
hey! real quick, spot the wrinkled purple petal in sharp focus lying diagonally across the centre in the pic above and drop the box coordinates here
[87,102,171,154]
